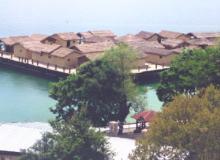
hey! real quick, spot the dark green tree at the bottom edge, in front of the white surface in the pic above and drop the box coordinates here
[21,110,113,160]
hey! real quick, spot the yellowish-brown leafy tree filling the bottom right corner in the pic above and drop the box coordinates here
[130,86,220,160]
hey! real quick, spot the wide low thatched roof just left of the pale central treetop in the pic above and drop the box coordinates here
[72,42,115,54]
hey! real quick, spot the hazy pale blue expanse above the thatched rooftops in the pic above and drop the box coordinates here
[0,0,220,35]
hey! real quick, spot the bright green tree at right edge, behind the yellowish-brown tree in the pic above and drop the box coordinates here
[157,47,220,102]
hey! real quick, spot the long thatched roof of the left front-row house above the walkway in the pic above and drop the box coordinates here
[19,41,61,53]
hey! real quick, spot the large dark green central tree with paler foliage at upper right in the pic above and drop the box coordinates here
[50,44,142,132]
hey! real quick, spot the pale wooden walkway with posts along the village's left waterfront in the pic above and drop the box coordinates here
[0,51,76,74]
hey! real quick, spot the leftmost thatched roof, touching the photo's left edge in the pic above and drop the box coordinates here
[0,36,32,46]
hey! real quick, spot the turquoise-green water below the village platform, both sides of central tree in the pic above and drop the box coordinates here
[0,67,162,123]
